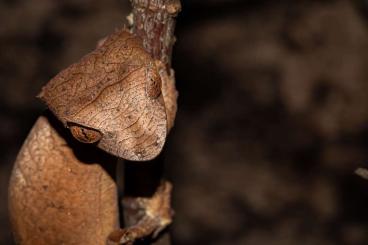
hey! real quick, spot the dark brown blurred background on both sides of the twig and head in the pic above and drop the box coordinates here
[0,0,368,245]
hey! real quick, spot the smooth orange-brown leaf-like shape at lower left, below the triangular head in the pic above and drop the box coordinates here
[9,116,119,245]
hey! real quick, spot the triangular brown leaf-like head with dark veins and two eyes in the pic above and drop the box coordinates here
[39,30,168,161]
